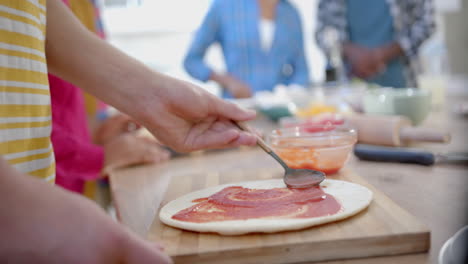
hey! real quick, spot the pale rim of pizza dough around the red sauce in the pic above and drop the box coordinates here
[159,179,372,235]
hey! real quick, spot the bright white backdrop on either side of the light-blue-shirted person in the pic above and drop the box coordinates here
[101,0,325,94]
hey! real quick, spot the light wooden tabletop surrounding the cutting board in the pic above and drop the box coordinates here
[110,89,468,264]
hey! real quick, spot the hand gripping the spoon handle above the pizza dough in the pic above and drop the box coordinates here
[140,77,256,152]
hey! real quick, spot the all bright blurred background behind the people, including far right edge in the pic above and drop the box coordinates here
[98,0,468,97]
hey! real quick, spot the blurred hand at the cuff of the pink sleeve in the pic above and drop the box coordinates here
[103,133,170,174]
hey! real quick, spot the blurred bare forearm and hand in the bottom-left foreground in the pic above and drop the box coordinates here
[0,159,172,264]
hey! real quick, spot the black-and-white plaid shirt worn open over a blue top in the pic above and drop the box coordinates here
[316,0,435,87]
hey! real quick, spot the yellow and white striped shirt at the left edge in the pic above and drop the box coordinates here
[0,0,55,182]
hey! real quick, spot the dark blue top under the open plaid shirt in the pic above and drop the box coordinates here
[346,0,406,88]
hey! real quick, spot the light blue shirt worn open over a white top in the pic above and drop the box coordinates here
[184,0,309,96]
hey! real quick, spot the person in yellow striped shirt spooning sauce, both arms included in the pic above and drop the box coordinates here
[0,0,256,263]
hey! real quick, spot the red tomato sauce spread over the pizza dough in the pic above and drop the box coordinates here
[172,186,341,223]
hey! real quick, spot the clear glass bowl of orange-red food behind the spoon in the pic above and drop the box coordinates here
[268,122,357,175]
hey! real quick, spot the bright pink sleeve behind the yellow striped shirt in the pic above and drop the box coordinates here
[49,75,104,193]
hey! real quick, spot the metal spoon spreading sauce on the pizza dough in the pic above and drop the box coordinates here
[234,122,325,188]
